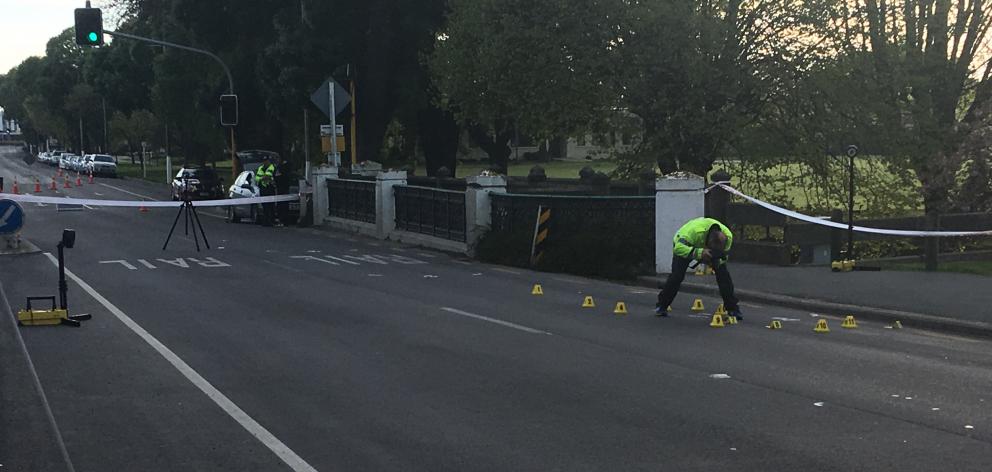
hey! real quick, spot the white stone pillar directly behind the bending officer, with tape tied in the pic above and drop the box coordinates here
[654,173,706,274]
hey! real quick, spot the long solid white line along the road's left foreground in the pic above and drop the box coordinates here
[45,252,317,472]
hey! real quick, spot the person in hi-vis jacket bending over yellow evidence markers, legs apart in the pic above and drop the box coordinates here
[655,218,743,320]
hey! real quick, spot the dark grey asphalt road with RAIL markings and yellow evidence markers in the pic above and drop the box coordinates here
[0,146,992,471]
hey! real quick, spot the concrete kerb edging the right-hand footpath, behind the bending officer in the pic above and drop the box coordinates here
[637,277,992,338]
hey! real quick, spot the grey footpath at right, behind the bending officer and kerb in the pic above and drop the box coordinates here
[638,261,992,337]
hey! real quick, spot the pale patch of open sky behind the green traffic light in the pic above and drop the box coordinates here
[0,0,107,74]
